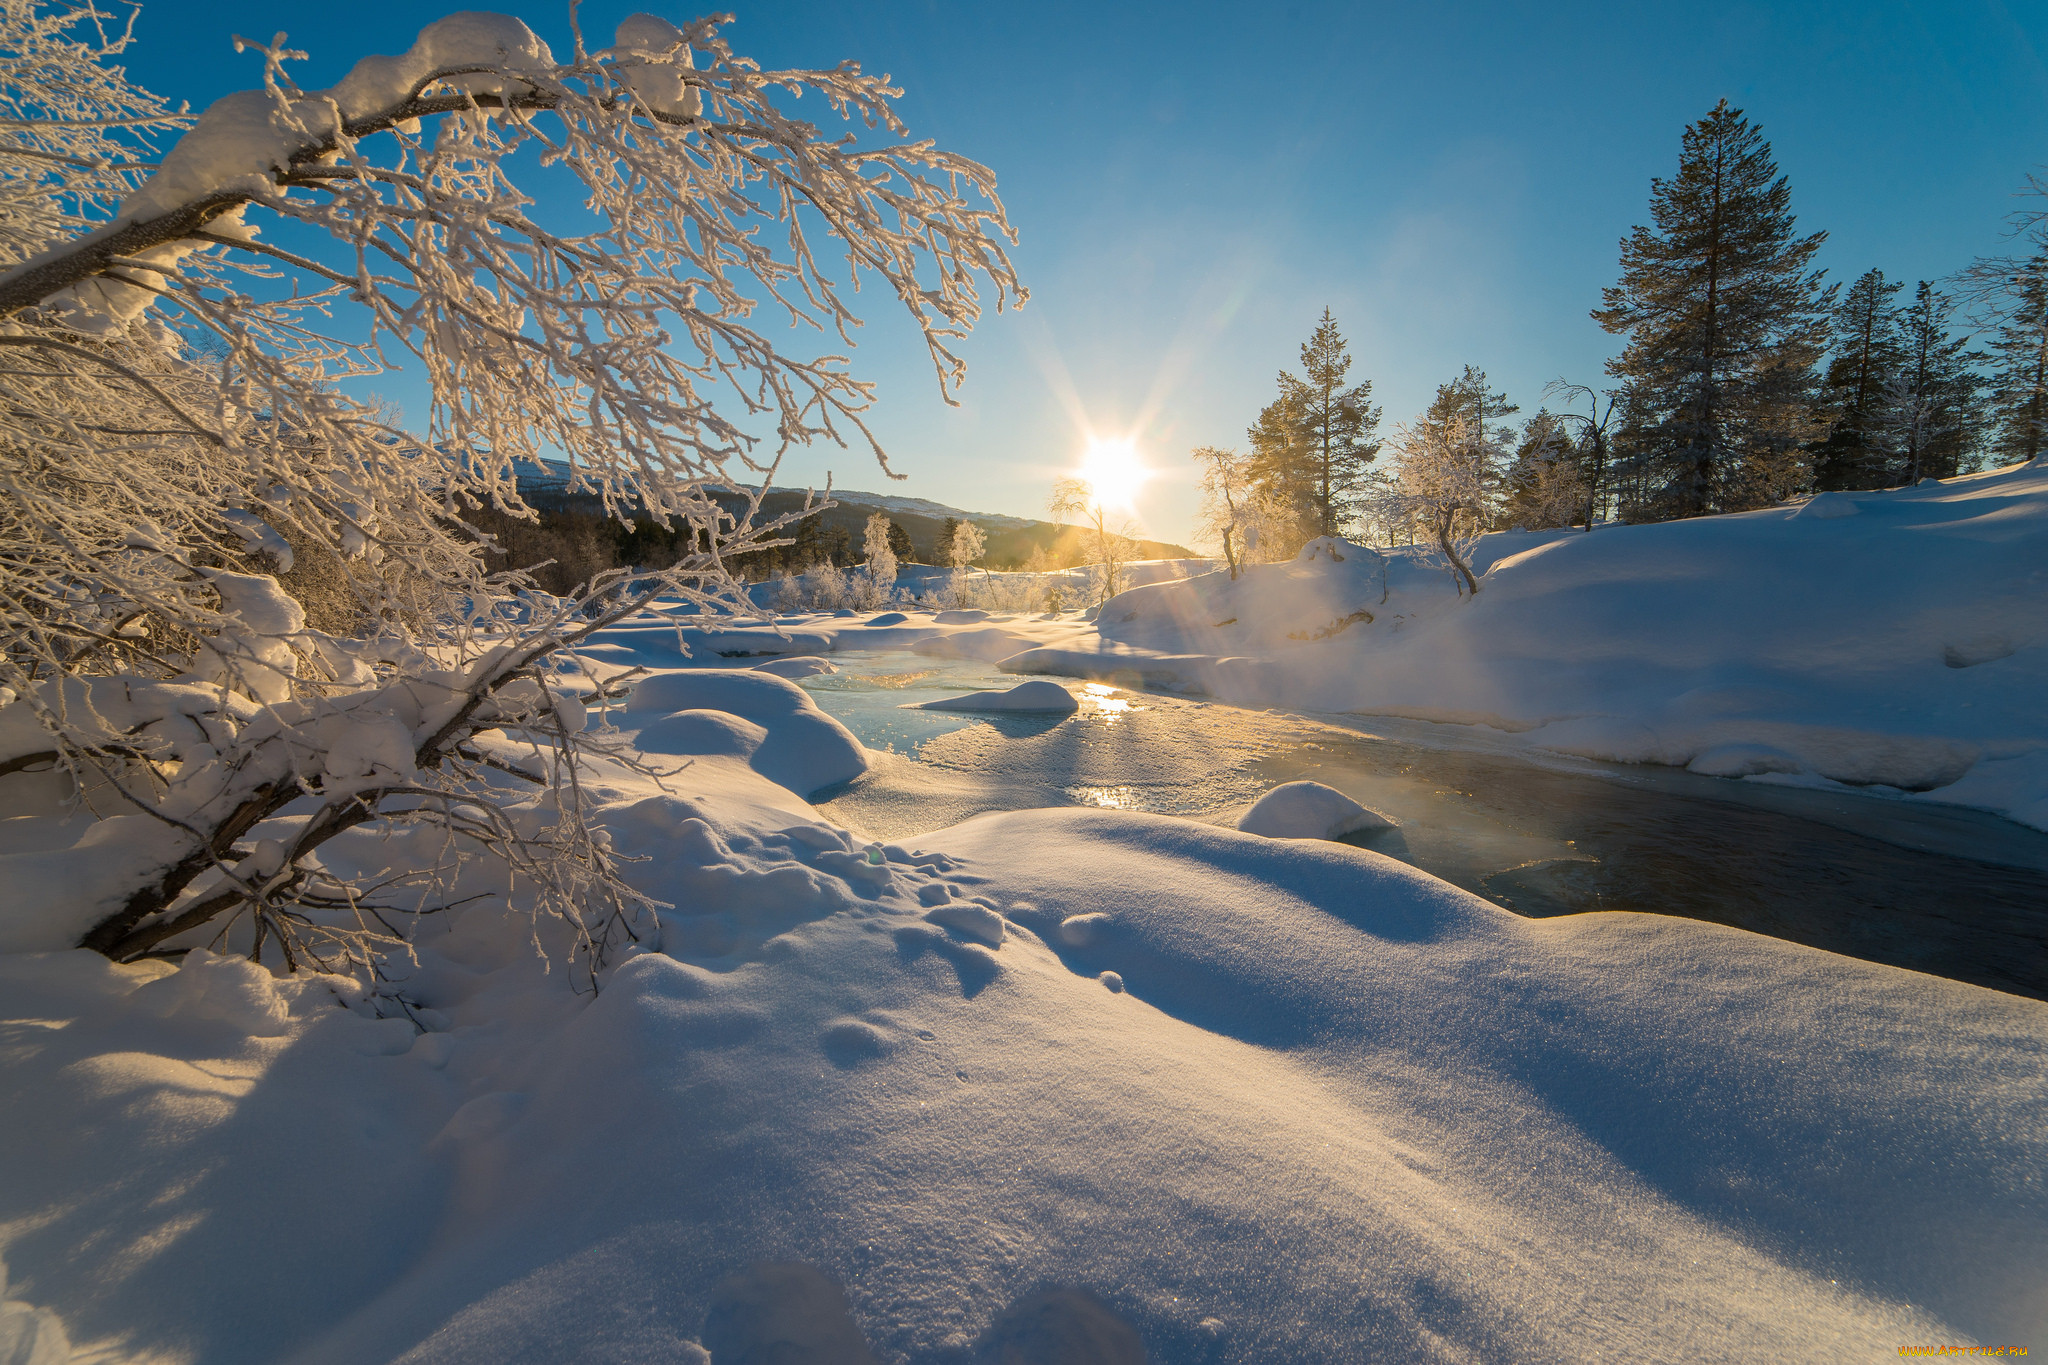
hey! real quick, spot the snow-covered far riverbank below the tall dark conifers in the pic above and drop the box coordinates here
[651,463,2048,829]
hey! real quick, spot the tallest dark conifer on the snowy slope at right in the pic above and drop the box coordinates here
[1593,100,1833,516]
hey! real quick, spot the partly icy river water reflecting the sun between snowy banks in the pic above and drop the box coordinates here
[803,653,2048,999]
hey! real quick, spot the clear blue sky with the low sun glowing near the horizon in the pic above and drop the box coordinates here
[129,0,2048,538]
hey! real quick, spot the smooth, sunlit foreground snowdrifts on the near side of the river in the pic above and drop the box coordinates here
[0,609,2048,1365]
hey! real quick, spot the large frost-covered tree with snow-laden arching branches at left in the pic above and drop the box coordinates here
[0,0,1022,982]
